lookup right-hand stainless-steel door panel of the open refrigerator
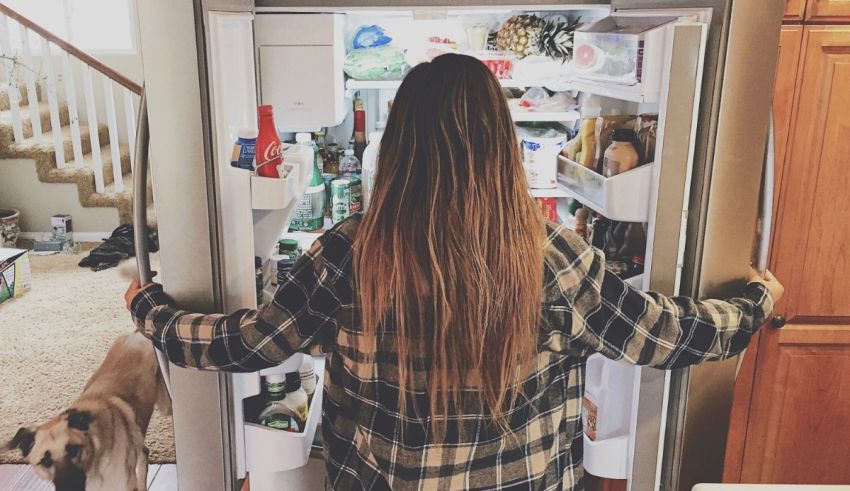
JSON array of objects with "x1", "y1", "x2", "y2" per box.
[{"x1": 612, "y1": 0, "x2": 783, "y2": 490}]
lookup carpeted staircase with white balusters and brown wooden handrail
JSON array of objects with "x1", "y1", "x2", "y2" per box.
[{"x1": 0, "y1": 4, "x2": 156, "y2": 228}]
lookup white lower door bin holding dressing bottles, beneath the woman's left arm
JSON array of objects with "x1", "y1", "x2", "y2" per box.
[{"x1": 238, "y1": 354, "x2": 325, "y2": 478}]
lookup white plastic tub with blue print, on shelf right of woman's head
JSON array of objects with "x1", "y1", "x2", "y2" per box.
[{"x1": 517, "y1": 126, "x2": 567, "y2": 189}]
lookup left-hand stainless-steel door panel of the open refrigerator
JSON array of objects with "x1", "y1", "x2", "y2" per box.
[{"x1": 138, "y1": 0, "x2": 235, "y2": 491}]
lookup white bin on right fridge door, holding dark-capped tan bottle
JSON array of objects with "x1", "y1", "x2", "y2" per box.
[{"x1": 558, "y1": 156, "x2": 655, "y2": 222}]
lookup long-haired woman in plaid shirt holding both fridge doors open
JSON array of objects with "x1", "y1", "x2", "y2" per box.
[{"x1": 127, "y1": 55, "x2": 782, "y2": 490}]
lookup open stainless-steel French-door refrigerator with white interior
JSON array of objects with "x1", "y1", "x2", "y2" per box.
[{"x1": 136, "y1": 0, "x2": 784, "y2": 491}]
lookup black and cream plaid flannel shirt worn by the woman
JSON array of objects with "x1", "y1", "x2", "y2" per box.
[{"x1": 131, "y1": 215, "x2": 773, "y2": 491}]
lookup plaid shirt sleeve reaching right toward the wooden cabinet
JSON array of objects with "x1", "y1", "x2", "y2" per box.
[{"x1": 544, "y1": 225, "x2": 773, "y2": 369}]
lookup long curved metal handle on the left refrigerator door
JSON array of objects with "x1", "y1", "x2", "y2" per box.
[{"x1": 133, "y1": 86, "x2": 171, "y2": 396}]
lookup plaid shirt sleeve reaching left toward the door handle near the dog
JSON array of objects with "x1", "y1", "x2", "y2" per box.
[{"x1": 131, "y1": 237, "x2": 340, "y2": 372}]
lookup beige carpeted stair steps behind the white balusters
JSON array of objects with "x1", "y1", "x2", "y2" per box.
[{"x1": 0, "y1": 84, "x2": 156, "y2": 229}]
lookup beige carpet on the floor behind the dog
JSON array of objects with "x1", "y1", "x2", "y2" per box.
[{"x1": 0, "y1": 248, "x2": 174, "y2": 463}]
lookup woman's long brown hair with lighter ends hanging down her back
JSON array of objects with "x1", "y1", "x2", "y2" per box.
[{"x1": 355, "y1": 55, "x2": 545, "y2": 433}]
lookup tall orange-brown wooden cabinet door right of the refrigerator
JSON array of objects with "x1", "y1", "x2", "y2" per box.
[{"x1": 740, "y1": 27, "x2": 850, "y2": 484}]
